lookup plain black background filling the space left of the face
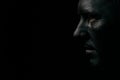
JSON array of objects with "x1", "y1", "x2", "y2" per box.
[{"x1": 3, "y1": 0, "x2": 90, "y2": 80}]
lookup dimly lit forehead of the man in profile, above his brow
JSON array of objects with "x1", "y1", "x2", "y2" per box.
[{"x1": 78, "y1": 0, "x2": 113, "y2": 12}]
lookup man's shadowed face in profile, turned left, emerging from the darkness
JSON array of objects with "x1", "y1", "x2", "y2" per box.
[{"x1": 74, "y1": 0, "x2": 118, "y2": 66}]
